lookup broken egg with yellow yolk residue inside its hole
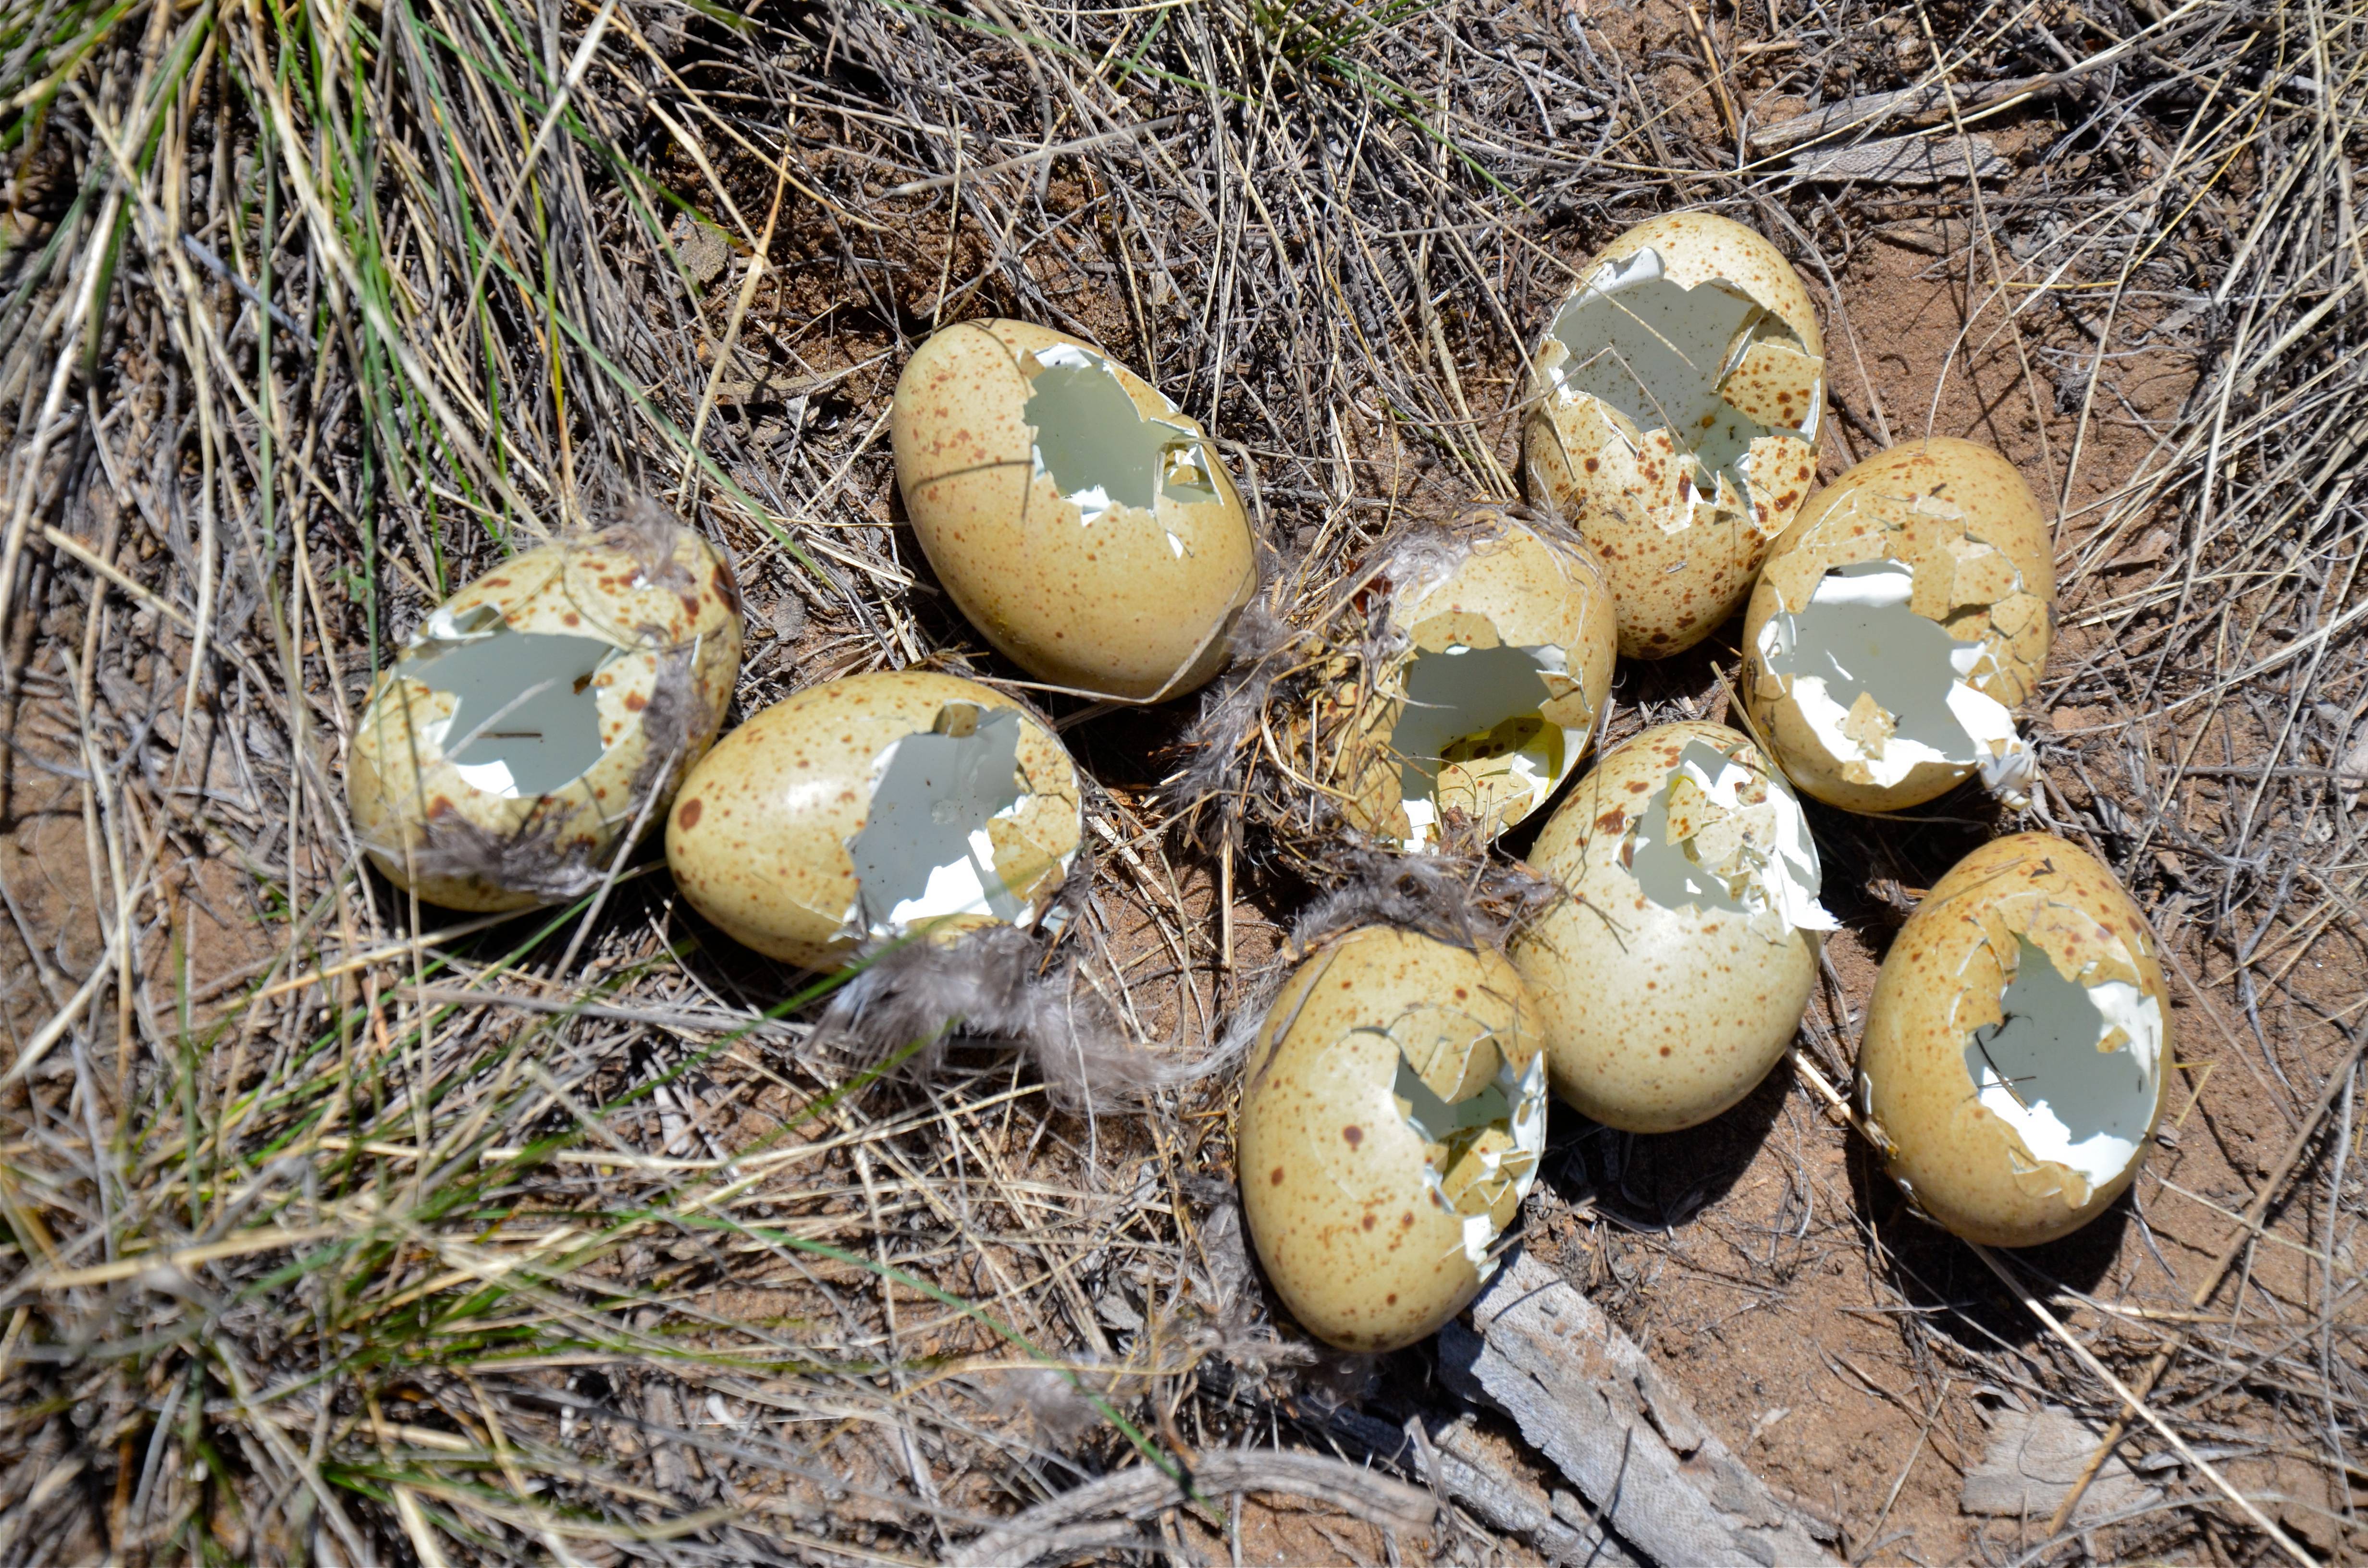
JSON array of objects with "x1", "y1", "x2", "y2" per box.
[{"x1": 1343, "y1": 507, "x2": 1617, "y2": 848}]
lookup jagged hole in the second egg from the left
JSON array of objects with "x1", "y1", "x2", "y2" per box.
[{"x1": 848, "y1": 703, "x2": 1066, "y2": 936}]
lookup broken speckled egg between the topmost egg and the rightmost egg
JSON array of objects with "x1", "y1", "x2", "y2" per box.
[{"x1": 1743, "y1": 436, "x2": 2056, "y2": 812}]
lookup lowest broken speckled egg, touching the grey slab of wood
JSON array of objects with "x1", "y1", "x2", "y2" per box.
[{"x1": 1236, "y1": 926, "x2": 1546, "y2": 1350}]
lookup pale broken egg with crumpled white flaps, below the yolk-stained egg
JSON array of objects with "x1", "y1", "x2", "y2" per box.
[{"x1": 1511, "y1": 723, "x2": 1833, "y2": 1132}]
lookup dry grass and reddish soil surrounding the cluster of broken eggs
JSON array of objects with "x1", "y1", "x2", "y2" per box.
[{"x1": 0, "y1": 0, "x2": 2368, "y2": 1563}]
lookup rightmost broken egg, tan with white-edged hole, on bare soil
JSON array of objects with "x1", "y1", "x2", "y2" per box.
[{"x1": 1859, "y1": 834, "x2": 2171, "y2": 1246}]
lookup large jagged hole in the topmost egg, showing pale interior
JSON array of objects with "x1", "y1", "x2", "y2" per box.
[{"x1": 1539, "y1": 246, "x2": 1824, "y2": 533}]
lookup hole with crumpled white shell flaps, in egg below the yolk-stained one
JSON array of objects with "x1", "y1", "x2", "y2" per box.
[{"x1": 1620, "y1": 741, "x2": 1838, "y2": 943}]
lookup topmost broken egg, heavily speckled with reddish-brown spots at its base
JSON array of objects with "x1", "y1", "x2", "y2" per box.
[{"x1": 1523, "y1": 213, "x2": 1825, "y2": 659}]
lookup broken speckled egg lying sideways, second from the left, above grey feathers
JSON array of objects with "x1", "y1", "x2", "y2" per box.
[{"x1": 666, "y1": 670, "x2": 1082, "y2": 969}]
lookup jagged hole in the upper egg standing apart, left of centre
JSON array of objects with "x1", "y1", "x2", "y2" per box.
[{"x1": 1021, "y1": 343, "x2": 1217, "y2": 557}]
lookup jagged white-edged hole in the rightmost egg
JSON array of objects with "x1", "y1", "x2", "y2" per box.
[{"x1": 1965, "y1": 936, "x2": 2162, "y2": 1189}]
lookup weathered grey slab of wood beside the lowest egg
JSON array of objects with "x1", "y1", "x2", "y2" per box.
[{"x1": 1440, "y1": 1253, "x2": 1835, "y2": 1568}]
